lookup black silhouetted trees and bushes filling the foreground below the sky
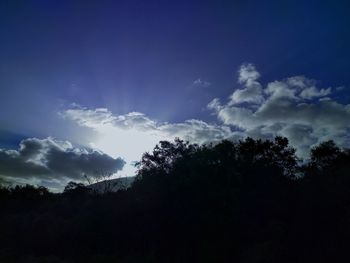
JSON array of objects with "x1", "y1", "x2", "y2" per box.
[{"x1": 0, "y1": 138, "x2": 350, "y2": 263}]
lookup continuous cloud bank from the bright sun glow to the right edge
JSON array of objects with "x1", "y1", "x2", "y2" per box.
[{"x1": 61, "y1": 64, "x2": 350, "y2": 165}]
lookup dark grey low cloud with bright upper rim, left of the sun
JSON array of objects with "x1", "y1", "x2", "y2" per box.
[{"x1": 0, "y1": 137, "x2": 125, "y2": 190}]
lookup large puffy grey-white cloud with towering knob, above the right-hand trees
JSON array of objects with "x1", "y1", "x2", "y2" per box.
[{"x1": 208, "y1": 64, "x2": 350, "y2": 156}]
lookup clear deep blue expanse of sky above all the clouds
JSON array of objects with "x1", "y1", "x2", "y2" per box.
[{"x1": 0, "y1": 0, "x2": 350, "y2": 188}]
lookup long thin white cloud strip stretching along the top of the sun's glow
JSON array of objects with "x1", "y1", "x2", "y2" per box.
[{"x1": 60, "y1": 107, "x2": 231, "y2": 146}]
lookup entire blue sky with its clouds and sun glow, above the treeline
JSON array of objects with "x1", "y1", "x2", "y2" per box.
[{"x1": 0, "y1": 0, "x2": 350, "y2": 190}]
